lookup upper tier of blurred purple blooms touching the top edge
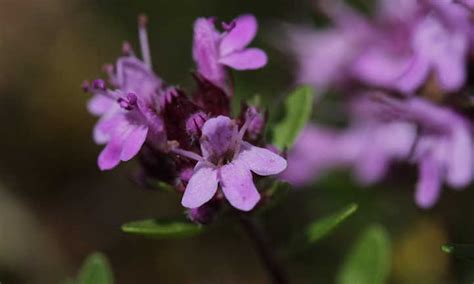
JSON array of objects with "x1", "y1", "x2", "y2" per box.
[{"x1": 290, "y1": 0, "x2": 472, "y2": 94}]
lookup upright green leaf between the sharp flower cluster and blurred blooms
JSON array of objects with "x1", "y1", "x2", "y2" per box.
[{"x1": 273, "y1": 86, "x2": 314, "y2": 150}]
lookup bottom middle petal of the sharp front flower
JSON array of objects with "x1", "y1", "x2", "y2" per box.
[{"x1": 219, "y1": 161, "x2": 260, "y2": 211}]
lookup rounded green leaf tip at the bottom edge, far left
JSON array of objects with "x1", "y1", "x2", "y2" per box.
[{"x1": 76, "y1": 253, "x2": 114, "y2": 284}]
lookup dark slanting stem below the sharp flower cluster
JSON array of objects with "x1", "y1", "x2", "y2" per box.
[{"x1": 239, "y1": 214, "x2": 289, "y2": 284}]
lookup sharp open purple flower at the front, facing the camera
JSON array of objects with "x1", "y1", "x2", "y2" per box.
[{"x1": 174, "y1": 116, "x2": 286, "y2": 211}]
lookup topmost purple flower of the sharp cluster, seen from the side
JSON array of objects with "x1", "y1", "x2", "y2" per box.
[{"x1": 193, "y1": 15, "x2": 267, "y2": 93}]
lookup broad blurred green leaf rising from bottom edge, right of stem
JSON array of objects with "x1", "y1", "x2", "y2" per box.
[{"x1": 337, "y1": 225, "x2": 391, "y2": 284}]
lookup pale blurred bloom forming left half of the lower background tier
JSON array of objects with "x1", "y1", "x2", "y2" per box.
[{"x1": 281, "y1": 121, "x2": 416, "y2": 186}]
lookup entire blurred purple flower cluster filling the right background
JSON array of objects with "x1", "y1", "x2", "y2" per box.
[{"x1": 284, "y1": 0, "x2": 474, "y2": 208}]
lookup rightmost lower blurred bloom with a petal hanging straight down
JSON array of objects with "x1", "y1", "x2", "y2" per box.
[{"x1": 386, "y1": 98, "x2": 474, "y2": 208}]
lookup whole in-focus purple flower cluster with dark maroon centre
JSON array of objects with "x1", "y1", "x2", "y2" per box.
[{"x1": 83, "y1": 15, "x2": 286, "y2": 213}]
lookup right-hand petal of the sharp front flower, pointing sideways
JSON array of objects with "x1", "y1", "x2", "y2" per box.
[{"x1": 237, "y1": 142, "x2": 287, "y2": 176}]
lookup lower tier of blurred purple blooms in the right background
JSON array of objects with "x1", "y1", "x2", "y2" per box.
[{"x1": 282, "y1": 96, "x2": 474, "y2": 208}]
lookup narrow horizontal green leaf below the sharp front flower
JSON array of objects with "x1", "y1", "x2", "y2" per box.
[{"x1": 122, "y1": 219, "x2": 203, "y2": 238}]
